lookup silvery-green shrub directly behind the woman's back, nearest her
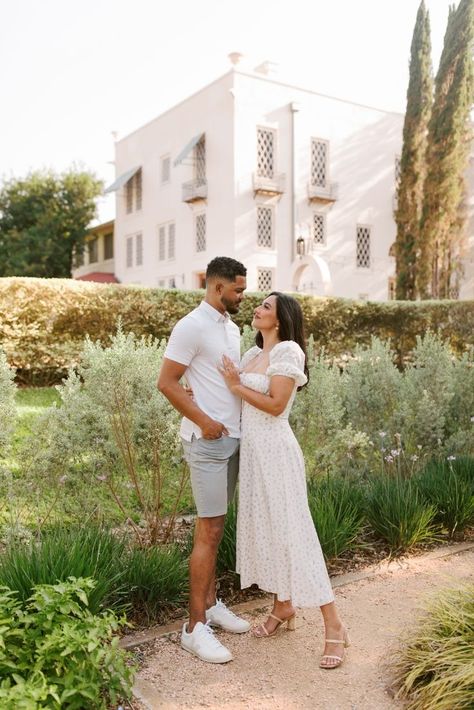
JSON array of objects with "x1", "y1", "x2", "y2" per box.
[{"x1": 291, "y1": 338, "x2": 369, "y2": 476}]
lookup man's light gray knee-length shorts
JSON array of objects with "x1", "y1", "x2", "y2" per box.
[{"x1": 181, "y1": 434, "x2": 240, "y2": 518}]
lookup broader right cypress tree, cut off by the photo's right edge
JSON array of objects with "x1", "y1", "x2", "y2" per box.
[{"x1": 417, "y1": 0, "x2": 474, "y2": 298}]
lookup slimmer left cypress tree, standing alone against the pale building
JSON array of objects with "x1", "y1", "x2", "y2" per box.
[{"x1": 395, "y1": 0, "x2": 433, "y2": 300}]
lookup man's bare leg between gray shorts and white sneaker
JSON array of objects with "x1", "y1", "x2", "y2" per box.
[{"x1": 188, "y1": 515, "x2": 225, "y2": 633}]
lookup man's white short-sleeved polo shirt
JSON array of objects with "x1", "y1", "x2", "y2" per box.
[{"x1": 164, "y1": 301, "x2": 240, "y2": 441}]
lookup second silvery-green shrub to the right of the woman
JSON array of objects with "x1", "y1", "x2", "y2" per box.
[{"x1": 342, "y1": 338, "x2": 402, "y2": 441}]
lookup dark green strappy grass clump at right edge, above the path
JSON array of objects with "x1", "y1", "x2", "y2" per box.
[{"x1": 415, "y1": 460, "x2": 474, "y2": 537}]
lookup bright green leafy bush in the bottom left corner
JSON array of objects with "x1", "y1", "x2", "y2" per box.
[{"x1": 0, "y1": 577, "x2": 134, "y2": 710}]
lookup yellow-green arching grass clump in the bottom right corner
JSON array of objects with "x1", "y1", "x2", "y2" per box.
[{"x1": 395, "y1": 584, "x2": 474, "y2": 710}]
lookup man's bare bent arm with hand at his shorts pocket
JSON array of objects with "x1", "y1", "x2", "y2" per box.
[{"x1": 157, "y1": 357, "x2": 229, "y2": 439}]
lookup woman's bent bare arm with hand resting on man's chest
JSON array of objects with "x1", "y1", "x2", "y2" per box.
[{"x1": 218, "y1": 355, "x2": 295, "y2": 417}]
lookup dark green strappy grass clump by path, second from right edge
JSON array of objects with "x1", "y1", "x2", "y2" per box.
[{"x1": 365, "y1": 475, "x2": 436, "y2": 553}]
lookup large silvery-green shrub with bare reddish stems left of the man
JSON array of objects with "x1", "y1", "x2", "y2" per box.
[{"x1": 26, "y1": 327, "x2": 181, "y2": 528}]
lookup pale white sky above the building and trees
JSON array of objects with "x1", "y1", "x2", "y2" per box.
[{"x1": 0, "y1": 0, "x2": 456, "y2": 195}]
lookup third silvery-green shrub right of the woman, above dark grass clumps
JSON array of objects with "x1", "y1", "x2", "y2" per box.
[{"x1": 396, "y1": 333, "x2": 455, "y2": 453}]
